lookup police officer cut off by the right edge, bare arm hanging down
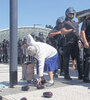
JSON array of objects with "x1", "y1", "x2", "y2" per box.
[{"x1": 81, "y1": 16, "x2": 90, "y2": 82}]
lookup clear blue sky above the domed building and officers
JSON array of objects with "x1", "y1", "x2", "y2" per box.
[{"x1": 0, "y1": 0, "x2": 90, "y2": 29}]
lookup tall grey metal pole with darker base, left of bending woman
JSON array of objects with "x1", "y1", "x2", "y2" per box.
[{"x1": 10, "y1": 0, "x2": 17, "y2": 87}]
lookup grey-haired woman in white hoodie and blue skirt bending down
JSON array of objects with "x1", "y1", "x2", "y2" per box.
[{"x1": 27, "y1": 34, "x2": 59, "y2": 86}]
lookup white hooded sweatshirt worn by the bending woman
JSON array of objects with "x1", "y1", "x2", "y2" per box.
[{"x1": 27, "y1": 34, "x2": 57, "y2": 77}]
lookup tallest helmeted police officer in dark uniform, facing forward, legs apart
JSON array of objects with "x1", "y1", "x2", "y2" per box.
[{"x1": 63, "y1": 7, "x2": 82, "y2": 80}]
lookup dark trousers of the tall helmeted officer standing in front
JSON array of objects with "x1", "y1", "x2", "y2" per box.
[{"x1": 63, "y1": 42, "x2": 82, "y2": 77}]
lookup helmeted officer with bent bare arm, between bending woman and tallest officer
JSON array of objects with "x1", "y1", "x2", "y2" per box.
[{"x1": 48, "y1": 17, "x2": 72, "y2": 77}]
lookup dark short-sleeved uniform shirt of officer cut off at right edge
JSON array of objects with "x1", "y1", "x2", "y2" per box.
[{"x1": 81, "y1": 18, "x2": 90, "y2": 41}]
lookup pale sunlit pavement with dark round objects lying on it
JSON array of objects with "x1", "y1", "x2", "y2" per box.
[{"x1": 0, "y1": 64, "x2": 90, "y2": 100}]
